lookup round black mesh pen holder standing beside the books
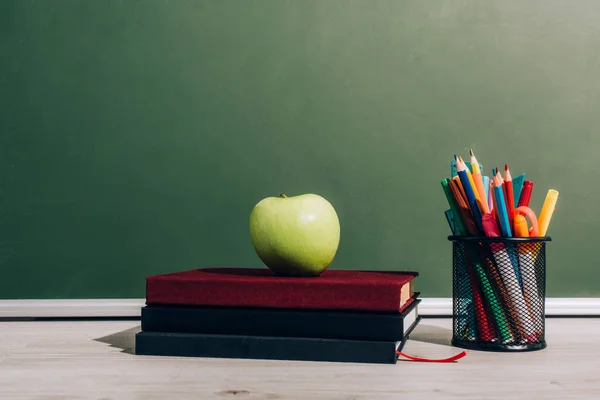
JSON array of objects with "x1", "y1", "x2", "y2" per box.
[{"x1": 448, "y1": 236, "x2": 551, "y2": 351}]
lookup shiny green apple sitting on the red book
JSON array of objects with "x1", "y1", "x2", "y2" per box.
[{"x1": 250, "y1": 194, "x2": 340, "y2": 276}]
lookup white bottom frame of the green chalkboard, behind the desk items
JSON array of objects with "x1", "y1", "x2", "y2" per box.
[{"x1": 0, "y1": 297, "x2": 600, "y2": 318}]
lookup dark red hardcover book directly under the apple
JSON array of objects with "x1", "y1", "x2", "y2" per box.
[{"x1": 146, "y1": 268, "x2": 418, "y2": 312}]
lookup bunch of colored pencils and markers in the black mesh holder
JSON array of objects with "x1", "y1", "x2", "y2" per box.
[{"x1": 442, "y1": 149, "x2": 558, "y2": 344}]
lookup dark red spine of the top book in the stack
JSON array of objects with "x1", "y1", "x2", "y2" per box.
[{"x1": 146, "y1": 278, "x2": 408, "y2": 312}]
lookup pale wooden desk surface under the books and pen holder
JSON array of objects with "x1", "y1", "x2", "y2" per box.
[{"x1": 0, "y1": 319, "x2": 600, "y2": 400}]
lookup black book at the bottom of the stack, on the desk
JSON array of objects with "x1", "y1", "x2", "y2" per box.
[{"x1": 135, "y1": 332, "x2": 404, "y2": 364}]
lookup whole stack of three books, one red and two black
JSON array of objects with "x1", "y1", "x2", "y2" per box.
[{"x1": 136, "y1": 268, "x2": 420, "y2": 364}]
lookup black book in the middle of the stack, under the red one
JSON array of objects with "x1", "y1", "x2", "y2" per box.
[{"x1": 141, "y1": 299, "x2": 420, "y2": 342}]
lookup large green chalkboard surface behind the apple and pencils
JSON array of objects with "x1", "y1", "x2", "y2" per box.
[{"x1": 0, "y1": 0, "x2": 600, "y2": 299}]
